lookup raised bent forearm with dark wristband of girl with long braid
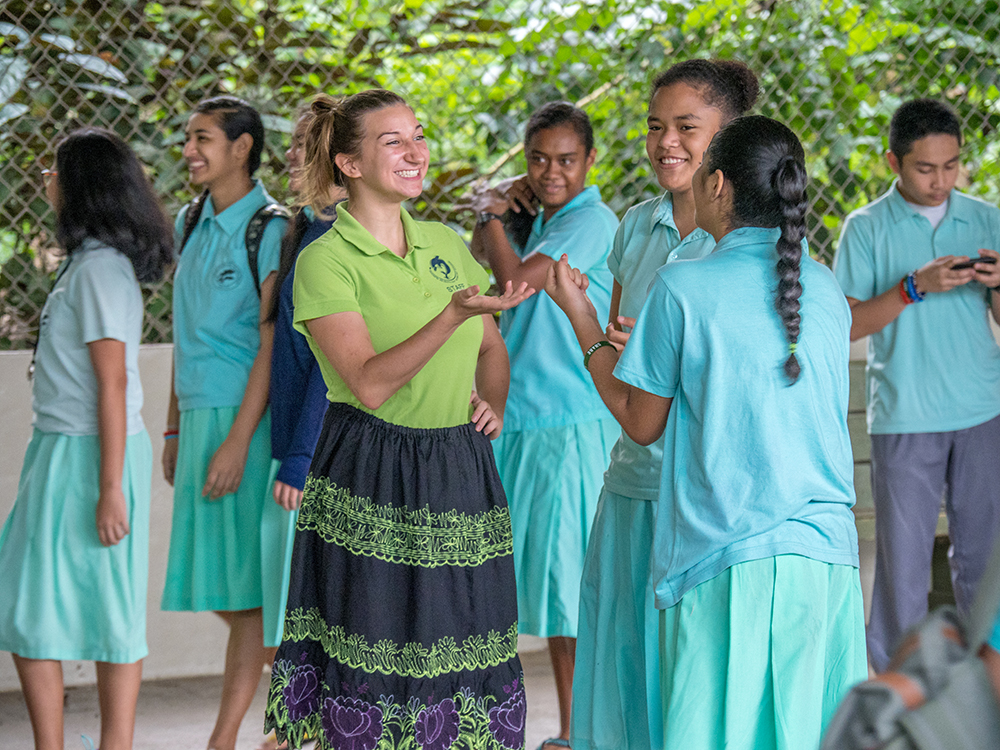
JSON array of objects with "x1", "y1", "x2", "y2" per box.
[{"x1": 545, "y1": 255, "x2": 673, "y2": 445}]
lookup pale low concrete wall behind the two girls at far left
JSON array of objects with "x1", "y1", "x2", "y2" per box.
[{"x1": 0, "y1": 345, "x2": 228, "y2": 690}]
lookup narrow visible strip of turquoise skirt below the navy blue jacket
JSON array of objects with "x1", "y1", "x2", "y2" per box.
[{"x1": 260, "y1": 460, "x2": 299, "y2": 648}]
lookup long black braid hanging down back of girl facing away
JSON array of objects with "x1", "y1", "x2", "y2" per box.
[{"x1": 771, "y1": 155, "x2": 809, "y2": 383}]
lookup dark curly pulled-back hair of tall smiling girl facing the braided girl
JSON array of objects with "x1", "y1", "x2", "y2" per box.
[{"x1": 649, "y1": 60, "x2": 760, "y2": 123}]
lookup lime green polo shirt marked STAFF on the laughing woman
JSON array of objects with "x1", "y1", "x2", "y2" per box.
[{"x1": 292, "y1": 203, "x2": 489, "y2": 428}]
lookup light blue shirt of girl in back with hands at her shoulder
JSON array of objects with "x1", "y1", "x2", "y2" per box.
[{"x1": 500, "y1": 186, "x2": 618, "y2": 431}]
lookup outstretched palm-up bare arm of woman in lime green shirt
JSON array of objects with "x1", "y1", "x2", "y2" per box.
[{"x1": 306, "y1": 282, "x2": 535, "y2": 409}]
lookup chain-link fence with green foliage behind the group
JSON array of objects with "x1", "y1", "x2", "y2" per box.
[{"x1": 0, "y1": 0, "x2": 1000, "y2": 349}]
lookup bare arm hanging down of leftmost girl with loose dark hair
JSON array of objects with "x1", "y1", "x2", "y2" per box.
[{"x1": 87, "y1": 339, "x2": 129, "y2": 547}]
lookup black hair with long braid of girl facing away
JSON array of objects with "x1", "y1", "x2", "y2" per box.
[{"x1": 705, "y1": 115, "x2": 809, "y2": 383}]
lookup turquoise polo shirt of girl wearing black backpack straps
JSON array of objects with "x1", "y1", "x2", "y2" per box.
[{"x1": 174, "y1": 180, "x2": 287, "y2": 411}]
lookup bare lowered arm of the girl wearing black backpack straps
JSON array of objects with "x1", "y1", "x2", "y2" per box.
[{"x1": 201, "y1": 272, "x2": 277, "y2": 500}]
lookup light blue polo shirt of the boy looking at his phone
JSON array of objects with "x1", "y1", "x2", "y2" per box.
[{"x1": 833, "y1": 183, "x2": 1000, "y2": 435}]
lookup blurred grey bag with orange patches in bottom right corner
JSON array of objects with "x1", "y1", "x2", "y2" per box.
[{"x1": 820, "y1": 544, "x2": 1000, "y2": 750}]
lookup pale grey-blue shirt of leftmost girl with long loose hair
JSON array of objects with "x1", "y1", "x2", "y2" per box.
[{"x1": 32, "y1": 239, "x2": 143, "y2": 435}]
